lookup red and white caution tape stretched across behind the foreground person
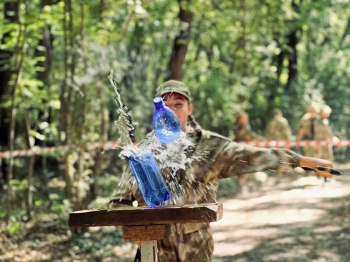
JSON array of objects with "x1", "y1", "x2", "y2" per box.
[{"x1": 0, "y1": 140, "x2": 350, "y2": 158}]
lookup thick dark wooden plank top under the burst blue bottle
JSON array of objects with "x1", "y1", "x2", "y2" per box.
[{"x1": 68, "y1": 203, "x2": 223, "y2": 227}]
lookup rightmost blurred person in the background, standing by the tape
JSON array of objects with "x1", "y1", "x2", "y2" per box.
[{"x1": 315, "y1": 105, "x2": 334, "y2": 161}]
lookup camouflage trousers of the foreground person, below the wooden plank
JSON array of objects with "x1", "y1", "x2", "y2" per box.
[{"x1": 158, "y1": 228, "x2": 214, "y2": 262}]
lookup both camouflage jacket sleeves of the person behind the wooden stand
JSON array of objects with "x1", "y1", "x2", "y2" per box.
[{"x1": 113, "y1": 131, "x2": 299, "y2": 205}]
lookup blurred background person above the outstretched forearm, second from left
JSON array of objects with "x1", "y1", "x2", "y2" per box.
[{"x1": 265, "y1": 109, "x2": 292, "y2": 141}]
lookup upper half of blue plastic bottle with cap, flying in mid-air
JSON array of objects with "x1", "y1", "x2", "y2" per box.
[{"x1": 153, "y1": 96, "x2": 181, "y2": 144}]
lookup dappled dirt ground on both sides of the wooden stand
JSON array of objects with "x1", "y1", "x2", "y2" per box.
[{"x1": 0, "y1": 165, "x2": 350, "y2": 262}]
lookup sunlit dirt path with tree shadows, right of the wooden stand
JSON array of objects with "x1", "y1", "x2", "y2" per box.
[{"x1": 212, "y1": 166, "x2": 350, "y2": 262}]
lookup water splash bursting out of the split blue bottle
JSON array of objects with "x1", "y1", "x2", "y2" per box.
[{"x1": 109, "y1": 73, "x2": 215, "y2": 208}]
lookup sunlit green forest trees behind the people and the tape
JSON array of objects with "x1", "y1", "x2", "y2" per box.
[{"x1": 0, "y1": 0, "x2": 350, "y2": 260}]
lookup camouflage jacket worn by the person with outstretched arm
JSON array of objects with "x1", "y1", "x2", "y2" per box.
[{"x1": 110, "y1": 117, "x2": 300, "y2": 234}]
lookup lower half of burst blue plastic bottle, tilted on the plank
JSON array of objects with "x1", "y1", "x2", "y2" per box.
[{"x1": 128, "y1": 151, "x2": 170, "y2": 208}]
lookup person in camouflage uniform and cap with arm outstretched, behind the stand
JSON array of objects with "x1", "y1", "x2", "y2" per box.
[{"x1": 110, "y1": 80, "x2": 332, "y2": 262}]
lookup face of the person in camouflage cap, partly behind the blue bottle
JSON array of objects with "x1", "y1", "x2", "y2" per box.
[{"x1": 163, "y1": 93, "x2": 192, "y2": 131}]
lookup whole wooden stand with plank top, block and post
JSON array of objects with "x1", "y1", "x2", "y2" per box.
[{"x1": 69, "y1": 203, "x2": 223, "y2": 262}]
